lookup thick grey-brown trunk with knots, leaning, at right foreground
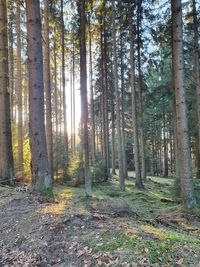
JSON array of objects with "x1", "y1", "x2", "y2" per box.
[{"x1": 171, "y1": 0, "x2": 196, "y2": 207}]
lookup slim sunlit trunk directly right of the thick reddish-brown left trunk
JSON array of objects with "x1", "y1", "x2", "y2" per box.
[{"x1": 44, "y1": 0, "x2": 53, "y2": 178}]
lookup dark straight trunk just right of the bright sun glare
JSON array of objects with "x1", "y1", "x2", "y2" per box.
[{"x1": 80, "y1": 0, "x2": 92, "y2": 197}]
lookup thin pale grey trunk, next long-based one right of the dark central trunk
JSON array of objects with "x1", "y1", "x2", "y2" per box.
[{"x1": 112, "y1": 0, "x2": 125, "y2": 191}]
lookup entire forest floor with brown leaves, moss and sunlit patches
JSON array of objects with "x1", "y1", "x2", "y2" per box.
[{"x1": 0, "y1": 177, "x2": 200, "y2": 267}]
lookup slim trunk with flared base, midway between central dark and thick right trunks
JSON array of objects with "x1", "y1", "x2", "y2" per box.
[{"x1": 128, "y1": 4, "x2": 144, "y2": 189}]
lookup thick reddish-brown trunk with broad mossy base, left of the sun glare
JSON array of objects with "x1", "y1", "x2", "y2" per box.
[{"x1": 26, "y1": 0, "x2": 52, "y2": 191}]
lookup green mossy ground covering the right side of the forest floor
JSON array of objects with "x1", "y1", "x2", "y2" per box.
[{"x1": 48, "y1": 178, "x2": 200, "y2": 266}]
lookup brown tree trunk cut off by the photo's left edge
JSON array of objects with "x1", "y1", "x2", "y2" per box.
[{"x1": 0, "y1": 1, "x2": 14, "y2": 185}]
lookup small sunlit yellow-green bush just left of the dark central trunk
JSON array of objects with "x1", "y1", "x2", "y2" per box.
[{"x1": 68, "y1": 155, "x2": 84, "y2": 186}]
